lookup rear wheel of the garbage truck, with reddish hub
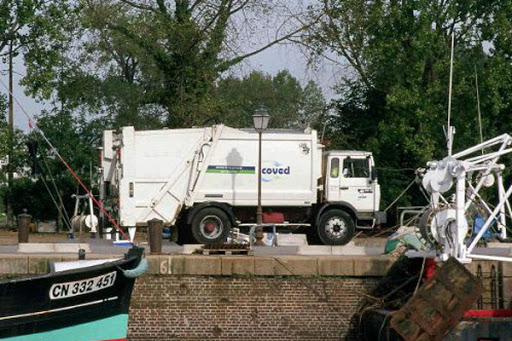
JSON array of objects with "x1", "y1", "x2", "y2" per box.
[{"x1": 192, "y1": 207, "x2": 231, "y2": 244}]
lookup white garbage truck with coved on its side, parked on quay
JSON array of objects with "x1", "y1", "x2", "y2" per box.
[{"x1": 99, "y1": 125, "x2": 385, "y2": 245}]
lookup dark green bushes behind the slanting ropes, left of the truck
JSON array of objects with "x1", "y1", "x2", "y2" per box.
[{"x1": 0, "y1": 111, "x2": 105, "y2": 220}]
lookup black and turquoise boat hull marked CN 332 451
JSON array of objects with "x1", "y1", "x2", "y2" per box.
[{"x1": 0, "y1": 249, "x2": 142, "y2": 341}]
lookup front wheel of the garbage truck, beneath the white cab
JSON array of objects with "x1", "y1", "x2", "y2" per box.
[{"x1": 317, "y1": 210, "x2": 355, "y2": 245}]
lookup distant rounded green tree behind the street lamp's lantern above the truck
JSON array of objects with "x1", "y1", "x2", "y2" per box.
[{"x1": 214, "y1": 70, "x2": 326, "y2": 129}]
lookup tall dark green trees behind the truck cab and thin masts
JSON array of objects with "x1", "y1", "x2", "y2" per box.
[{"x1": 302, "y1": 0, "x2": 512, "y2": 207}]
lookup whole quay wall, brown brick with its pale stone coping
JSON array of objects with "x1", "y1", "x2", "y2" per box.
[{"x1": 0, "y1": 254, "x2": 512, "y2": 341}]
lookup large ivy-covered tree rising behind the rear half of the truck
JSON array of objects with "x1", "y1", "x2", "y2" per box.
[{"x1": 30, "y1": 0, "x2": 312, "y2": 128}]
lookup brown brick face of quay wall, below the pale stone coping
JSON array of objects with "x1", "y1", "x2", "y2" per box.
[{"x1": 128, "y1": 274, "x2": 378, "y2": 341}]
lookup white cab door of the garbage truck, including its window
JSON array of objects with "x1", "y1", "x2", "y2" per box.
[{"x1": 339, "y1": 156, "x2": 375, "y2": 212}]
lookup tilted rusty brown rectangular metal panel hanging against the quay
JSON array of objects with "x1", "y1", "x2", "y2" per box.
[{"x1": 391, "y1": 258, "x2": 483, "y2": 341}]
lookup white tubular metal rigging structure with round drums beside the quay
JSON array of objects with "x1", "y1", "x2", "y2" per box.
[{"x1": 419, "y1": 134, "x2": 512, "y2": 262}]
